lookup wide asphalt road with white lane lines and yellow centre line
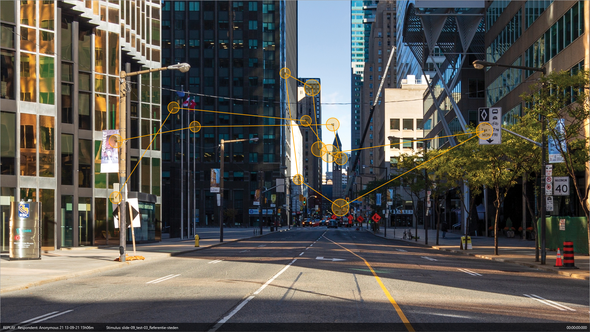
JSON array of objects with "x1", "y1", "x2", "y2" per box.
[{"x1": 0, "y1": 227, "x2": 589, "y2": 331}]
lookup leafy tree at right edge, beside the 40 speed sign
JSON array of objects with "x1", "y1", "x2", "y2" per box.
[{"x1": 522, "y1": 71, "x2": 590, "y2": 252}]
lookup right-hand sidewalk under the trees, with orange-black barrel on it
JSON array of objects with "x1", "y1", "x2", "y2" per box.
[{"x1": 363, "y1": 224, "x2": 590, "y2": 280}]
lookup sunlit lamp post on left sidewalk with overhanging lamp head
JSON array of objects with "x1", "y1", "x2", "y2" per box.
[{"x1": 119, "y1": 63, "x2": 191, "y2": 262}]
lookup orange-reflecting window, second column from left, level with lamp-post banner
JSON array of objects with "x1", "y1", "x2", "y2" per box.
[{"x1": 20, "y1": 113, "x2": 37, "y2": 176}]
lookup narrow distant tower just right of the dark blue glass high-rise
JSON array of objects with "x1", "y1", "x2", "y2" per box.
[{"x1": 297, "y1": 78, "x2": 322, "y2": 211}]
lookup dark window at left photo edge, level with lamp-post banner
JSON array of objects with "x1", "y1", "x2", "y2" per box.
[{"x1": 0, "y1": 112, "x2": 16, "y2": 175}]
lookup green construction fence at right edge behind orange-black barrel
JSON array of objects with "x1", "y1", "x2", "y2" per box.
[{"x1": 537, "y1": 217, "x2": 588, "y2": 255}]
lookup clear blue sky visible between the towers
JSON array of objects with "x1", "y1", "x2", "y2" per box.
[{"x1": 298, "y1": 0, "x2": 351, "y2": 150}]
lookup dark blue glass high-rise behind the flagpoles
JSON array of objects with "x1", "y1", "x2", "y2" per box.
[{"x1": 162, "y1": 0, "x2": 297, "y2": 237}]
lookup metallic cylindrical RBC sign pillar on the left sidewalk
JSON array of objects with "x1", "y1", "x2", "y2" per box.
[{"x1": 8, "y1": 201, "x2": 41, "y2": 260}]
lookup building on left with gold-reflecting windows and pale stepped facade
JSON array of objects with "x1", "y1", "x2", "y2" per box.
[{"x1": 0, "y1": 0, "x2": 162, "y2": 251}]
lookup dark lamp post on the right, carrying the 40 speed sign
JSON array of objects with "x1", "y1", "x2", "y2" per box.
[{"x1": 473, "y1": 60, "x2": 547, "y2": 265}]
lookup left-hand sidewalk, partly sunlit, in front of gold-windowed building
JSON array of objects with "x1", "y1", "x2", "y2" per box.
[{"x1": 0, "y1": 227, "x2": 287, "y2": 294}]
